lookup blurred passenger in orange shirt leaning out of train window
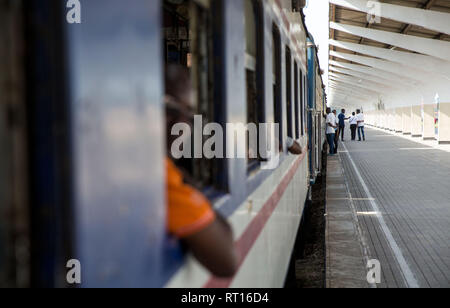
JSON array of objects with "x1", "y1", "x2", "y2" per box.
[{"x1": 165, "y1": 65, "x2": 238, "y2": 277}]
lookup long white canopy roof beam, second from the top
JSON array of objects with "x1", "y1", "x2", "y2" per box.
[{"x1": 330, "y1": 21, "x2": 450, "y2": 61}]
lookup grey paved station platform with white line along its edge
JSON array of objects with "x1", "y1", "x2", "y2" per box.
[{"x1": 326, "y1": 128, "x2": 450, "y2": 288}]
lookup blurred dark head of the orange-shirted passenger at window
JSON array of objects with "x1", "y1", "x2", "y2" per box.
[{"x1": 164, "y1": 65, "x2": 194, "y2": 151}]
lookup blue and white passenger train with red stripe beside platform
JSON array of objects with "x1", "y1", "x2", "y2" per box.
[{"x1": 0, "y1": 0, "x2": 326, "y2": 287}]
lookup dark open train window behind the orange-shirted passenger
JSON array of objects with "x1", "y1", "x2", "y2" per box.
[{"x1": 163, "y1": 0, "x2": 220, "y2": 189}]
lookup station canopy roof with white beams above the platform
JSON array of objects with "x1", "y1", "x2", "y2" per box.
[{"x1": 329, "y1": 0, "x2": 450, "y2": 109}]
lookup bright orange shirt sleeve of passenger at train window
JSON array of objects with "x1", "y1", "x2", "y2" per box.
[{"x1": 166, "y1": 159, "x2": 216, "y2": 238}]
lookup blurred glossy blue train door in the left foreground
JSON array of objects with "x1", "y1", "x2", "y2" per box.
[{"x1": 63, "y1": 0, "x2": 166, "y2": 287}]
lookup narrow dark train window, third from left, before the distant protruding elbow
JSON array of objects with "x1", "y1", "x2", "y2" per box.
[{"x1": 272, "y1": 25, "x2": 283, "y2": 146}]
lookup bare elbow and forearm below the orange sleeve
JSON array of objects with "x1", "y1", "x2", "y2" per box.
[{"x1": 183, "y1": 215, "x2": 238, "y2": 278}]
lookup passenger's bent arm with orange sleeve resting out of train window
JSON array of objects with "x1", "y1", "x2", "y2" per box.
[{"x1": 166, "y1": 160, "x2": 238, "y2": 277}]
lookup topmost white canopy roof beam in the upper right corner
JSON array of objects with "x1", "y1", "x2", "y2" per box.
[{"x1": 330, "y1": 0, "x2": 450, "y2": 34}]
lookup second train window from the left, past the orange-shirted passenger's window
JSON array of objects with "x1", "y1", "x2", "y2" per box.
[{"x1": 244, "y1": 0, "x2": 265, "y2": 170}]
